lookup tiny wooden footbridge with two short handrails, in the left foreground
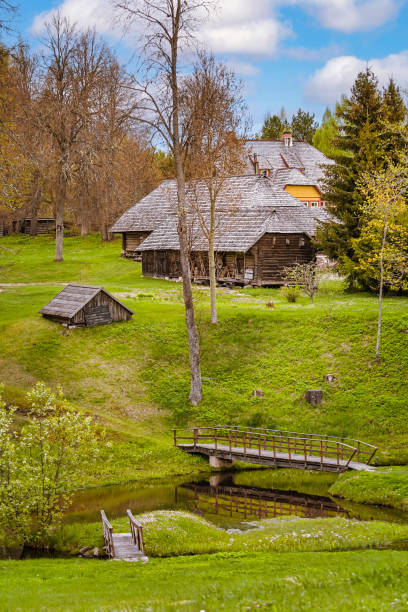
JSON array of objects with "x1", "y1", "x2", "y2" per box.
[{"x1": 101, "y1": 510, "x2": 147, "y2": 561}]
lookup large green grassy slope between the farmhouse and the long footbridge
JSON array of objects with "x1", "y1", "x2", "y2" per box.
[{"x1": 0, "y1": 236, "x2": 408, "y2": 482}]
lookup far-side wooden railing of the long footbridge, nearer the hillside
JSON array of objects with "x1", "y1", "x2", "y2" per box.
[{"x1": 174, "y1": 426, "x2": 377, "y2": 465}]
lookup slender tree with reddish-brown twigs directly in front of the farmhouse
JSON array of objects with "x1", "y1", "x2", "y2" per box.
[{"x1": 182, "y1": 53, "x2": 248, "y2": 323}]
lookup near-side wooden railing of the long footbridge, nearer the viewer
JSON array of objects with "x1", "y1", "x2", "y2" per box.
[{"x1": 174, "y1": 427, "x2": 357, "y2": 468}]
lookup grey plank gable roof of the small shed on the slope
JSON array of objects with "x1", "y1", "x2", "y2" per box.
[{"x1": 39, "y1": 283, "x2": 134, "y2": 319}]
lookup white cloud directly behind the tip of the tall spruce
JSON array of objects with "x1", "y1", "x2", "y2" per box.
[{"x1": 305, "y1": 51, "x2": 408, "y2": 104}]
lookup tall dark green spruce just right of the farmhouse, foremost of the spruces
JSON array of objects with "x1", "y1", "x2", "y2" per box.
[{"x1": 317, "y1": 68, "x2": 385, "y2": 286}]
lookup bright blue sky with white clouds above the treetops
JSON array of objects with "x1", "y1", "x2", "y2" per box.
[{"x1": 5, "y1": 0, "x2": 408, "y2": 129}]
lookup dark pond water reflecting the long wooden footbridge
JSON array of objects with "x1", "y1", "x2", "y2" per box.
[{"x1": 65, "y1": 470, "x2": 408, "y2": 529}]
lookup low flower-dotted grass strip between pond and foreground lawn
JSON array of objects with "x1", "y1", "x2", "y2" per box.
[{"x1": 49, "y1": 510, "x2": 408, "y2": 557}]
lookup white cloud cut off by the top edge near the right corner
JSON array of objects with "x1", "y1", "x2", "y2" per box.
[{"x1": 300, "y1": 0, "x2": 402, "y2": 33}]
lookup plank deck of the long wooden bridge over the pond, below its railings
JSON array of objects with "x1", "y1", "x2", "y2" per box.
[{"x1": 177, "y1": 442, "x2": 375, "y2": 472}]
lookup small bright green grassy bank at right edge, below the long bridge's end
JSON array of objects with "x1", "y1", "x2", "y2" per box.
[{"x1": 330, "y1": 466, "x2": 408, "y2": 511}]
